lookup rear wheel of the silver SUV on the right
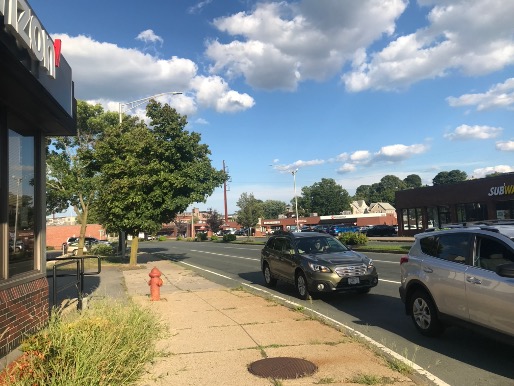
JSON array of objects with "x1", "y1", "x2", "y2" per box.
[{"x1": 410, "y1": 291, "x2": 444, "y2": 336}]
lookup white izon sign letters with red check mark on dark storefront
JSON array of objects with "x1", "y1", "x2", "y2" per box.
[{"x1": 0, "y1": 0, "x2": 61, "y2": 79}]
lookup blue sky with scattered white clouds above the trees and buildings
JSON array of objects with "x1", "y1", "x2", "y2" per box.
[{"x1": 28, "y1": 0, "x2": 514, "y2": 214}]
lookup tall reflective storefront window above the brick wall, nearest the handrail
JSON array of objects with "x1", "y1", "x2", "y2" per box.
[{"x1": 8, "y1": 130, "x2": 35, "y2": 277}]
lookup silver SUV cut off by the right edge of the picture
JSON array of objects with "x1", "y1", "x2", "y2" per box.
[{"x1": 400, "y1": 222, "x2": 514, "y2": 342}]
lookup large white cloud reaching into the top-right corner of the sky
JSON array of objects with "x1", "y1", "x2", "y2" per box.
[{"x1": 342, "y1": 0, "x2": 514, "y2": 92}]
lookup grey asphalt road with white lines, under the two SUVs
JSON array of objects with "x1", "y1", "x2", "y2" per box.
[{"x1": 136, "y1": 241, "x2": 514, "y2": 386}]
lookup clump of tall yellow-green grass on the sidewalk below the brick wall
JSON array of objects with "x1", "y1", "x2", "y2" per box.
[{"x1": 7, "y1": 301, "x2": 163, "y2": 386}]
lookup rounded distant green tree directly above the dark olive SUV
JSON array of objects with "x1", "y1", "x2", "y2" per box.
[{"x1": 298, "y1": 178, "x2": 350, "y2": 216}]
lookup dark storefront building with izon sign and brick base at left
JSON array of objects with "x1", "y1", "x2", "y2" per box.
[{"x1": 0, "y1": 0, "x2": 76, "y2": 357}]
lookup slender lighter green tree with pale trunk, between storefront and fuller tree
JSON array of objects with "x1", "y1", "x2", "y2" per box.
[{"x1": 46, "y1": 100, "x2": 117, "y2": 255}]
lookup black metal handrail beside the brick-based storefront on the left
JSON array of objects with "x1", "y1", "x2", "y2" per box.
[{"x1": 47, "y1": 256, "x2": 102, "y2": 310}]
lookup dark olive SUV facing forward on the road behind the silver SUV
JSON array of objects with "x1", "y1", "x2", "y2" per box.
[{"x1": 261, "y1": 232, "x2": 378, "y2": 299}]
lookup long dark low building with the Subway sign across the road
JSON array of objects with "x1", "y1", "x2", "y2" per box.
[{"x1": 396, "y1": 173, "x2": 514, "y2": 236}]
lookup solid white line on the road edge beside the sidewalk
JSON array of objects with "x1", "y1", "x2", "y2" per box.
[{"x1": 174, "y1": 260, "x2": 450, "y2": 386}]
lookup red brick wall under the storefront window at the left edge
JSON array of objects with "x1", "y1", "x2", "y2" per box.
[{"x1": 0, "y1": 277, "x2": 49, "y2": 357}]
